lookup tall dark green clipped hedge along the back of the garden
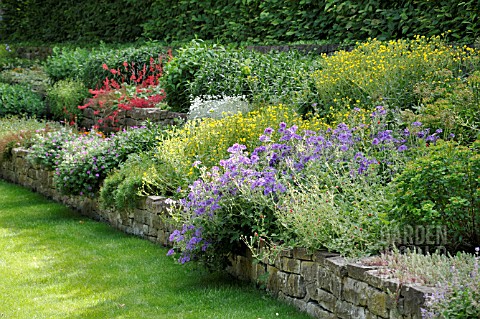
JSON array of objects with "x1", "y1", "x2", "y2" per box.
[{"x1": 0, "y1": 0, "x2": 480, "y2": 43}]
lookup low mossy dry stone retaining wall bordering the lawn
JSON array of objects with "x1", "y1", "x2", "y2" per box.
[{"x1": 0, "y1": 149, "x2": 434, "y2": 319}]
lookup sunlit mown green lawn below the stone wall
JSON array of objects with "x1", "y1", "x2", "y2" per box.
[{"x1": 0, "y1": 181, "x2": 308, "y2": 319}]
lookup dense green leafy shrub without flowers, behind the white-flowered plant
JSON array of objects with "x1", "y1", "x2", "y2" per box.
[{"x1": 161, "y1": 40, "x2": 319, "y2": 112}]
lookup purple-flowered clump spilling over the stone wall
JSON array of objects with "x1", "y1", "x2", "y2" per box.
[{"x1": 169, "y1": 116, "x2": 442, "y2": 264}]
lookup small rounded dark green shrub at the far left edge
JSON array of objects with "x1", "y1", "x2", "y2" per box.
[{"x1": 0, "y1": 83, "x2": 46, "y2": 117}]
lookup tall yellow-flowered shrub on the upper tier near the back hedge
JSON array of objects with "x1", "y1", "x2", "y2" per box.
[{"x1": 307, "y1": 37, "x2": 478, "y2": 115}]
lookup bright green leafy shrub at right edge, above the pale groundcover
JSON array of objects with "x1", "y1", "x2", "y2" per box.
[{"x1": 392, "y1": 141, "x2": 480, "y2": 251}]
